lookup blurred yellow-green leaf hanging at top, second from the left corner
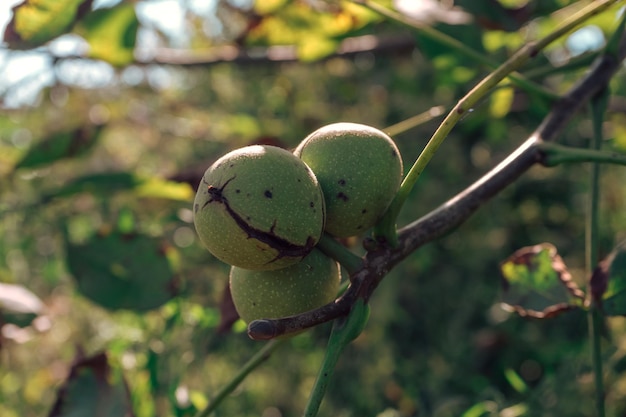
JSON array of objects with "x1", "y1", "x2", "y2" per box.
[{"x1": 77, "y1": 2, "x2": 139, "y2": 67}]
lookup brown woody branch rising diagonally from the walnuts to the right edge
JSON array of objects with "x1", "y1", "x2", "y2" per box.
[{"x1": 248, "y1": 35, "x2": 626, "y2": 340}]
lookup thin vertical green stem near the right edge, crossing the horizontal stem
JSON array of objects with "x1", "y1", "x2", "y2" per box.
[{"x1": 585, "y1": 90, "x2": 608, "y2": 417}]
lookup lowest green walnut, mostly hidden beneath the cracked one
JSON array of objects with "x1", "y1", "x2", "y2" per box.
[{"x1": 230, "y1": 249, "x2": 340, "y2": 323}]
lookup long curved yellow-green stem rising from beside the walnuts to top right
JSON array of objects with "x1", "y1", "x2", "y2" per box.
[{"x1": 372, "y1": 0, "x2": 616, "y2": 246}]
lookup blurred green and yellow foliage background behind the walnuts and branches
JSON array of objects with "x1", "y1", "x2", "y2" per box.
[{"x1": 0, "y1": 0, "x2": 626, "y2": 417}]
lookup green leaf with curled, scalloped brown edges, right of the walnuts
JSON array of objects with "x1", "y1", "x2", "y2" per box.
[{"x1": 500, "y1": 243, "x2": 585, "y2": 318}]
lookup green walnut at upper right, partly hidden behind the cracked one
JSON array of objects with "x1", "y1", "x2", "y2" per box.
[{"x1": 294, "y1": 123, "x2": 403, "y2": 237}]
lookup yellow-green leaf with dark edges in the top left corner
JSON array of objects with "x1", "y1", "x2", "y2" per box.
[{"x1": 4, "y1": 0, "x2": 92, "y2": 49}]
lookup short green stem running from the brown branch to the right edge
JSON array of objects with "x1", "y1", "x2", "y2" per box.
[{"x1": 538, "y1": 142, "x2": 626, "y2": 167}]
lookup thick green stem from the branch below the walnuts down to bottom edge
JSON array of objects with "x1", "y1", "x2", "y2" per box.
[{"x1": 304, "y1": 298, "x2": 369, "y2": 417}]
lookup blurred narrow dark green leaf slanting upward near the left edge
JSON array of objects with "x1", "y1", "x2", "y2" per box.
[{"x1": 14, "y1": 125, "x2": 105, "y2": 170}]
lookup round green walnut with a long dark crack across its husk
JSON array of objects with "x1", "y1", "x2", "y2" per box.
[{"x1": 193, "y1": 145, "x2": 325, "y2": 270}]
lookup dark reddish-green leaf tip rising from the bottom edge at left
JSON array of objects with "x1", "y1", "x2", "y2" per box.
[{"x1": 48, "y1": 353, "x2": 135, "y2": 417}]
